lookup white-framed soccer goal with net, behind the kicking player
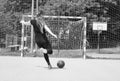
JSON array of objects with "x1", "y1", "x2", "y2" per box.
[{"x1": 21, "y1": 15, "x2": 86, "y2": 58}]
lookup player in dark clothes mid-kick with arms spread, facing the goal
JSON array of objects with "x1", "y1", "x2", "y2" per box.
[{"x1": 20, "y1": 14, "x2": 57, "y2": 69}]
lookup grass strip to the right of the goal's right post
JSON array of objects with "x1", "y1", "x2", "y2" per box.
[{"x1": 86, "y1": 47, "x2": 120, "y2": 60}]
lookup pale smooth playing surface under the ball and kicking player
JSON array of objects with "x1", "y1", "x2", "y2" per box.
[{"x1": 0, "y1": 56, "x2": 120, "y2": 81}]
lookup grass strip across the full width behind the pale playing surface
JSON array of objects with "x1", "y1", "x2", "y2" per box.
[{"x1": 0, "y1": 47, "x2": 120, "y2": 60}]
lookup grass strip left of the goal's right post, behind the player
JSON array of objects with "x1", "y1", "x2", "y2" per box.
[{"x1": 0, "y1": 49, "x2": 82, "y2": 58}]
